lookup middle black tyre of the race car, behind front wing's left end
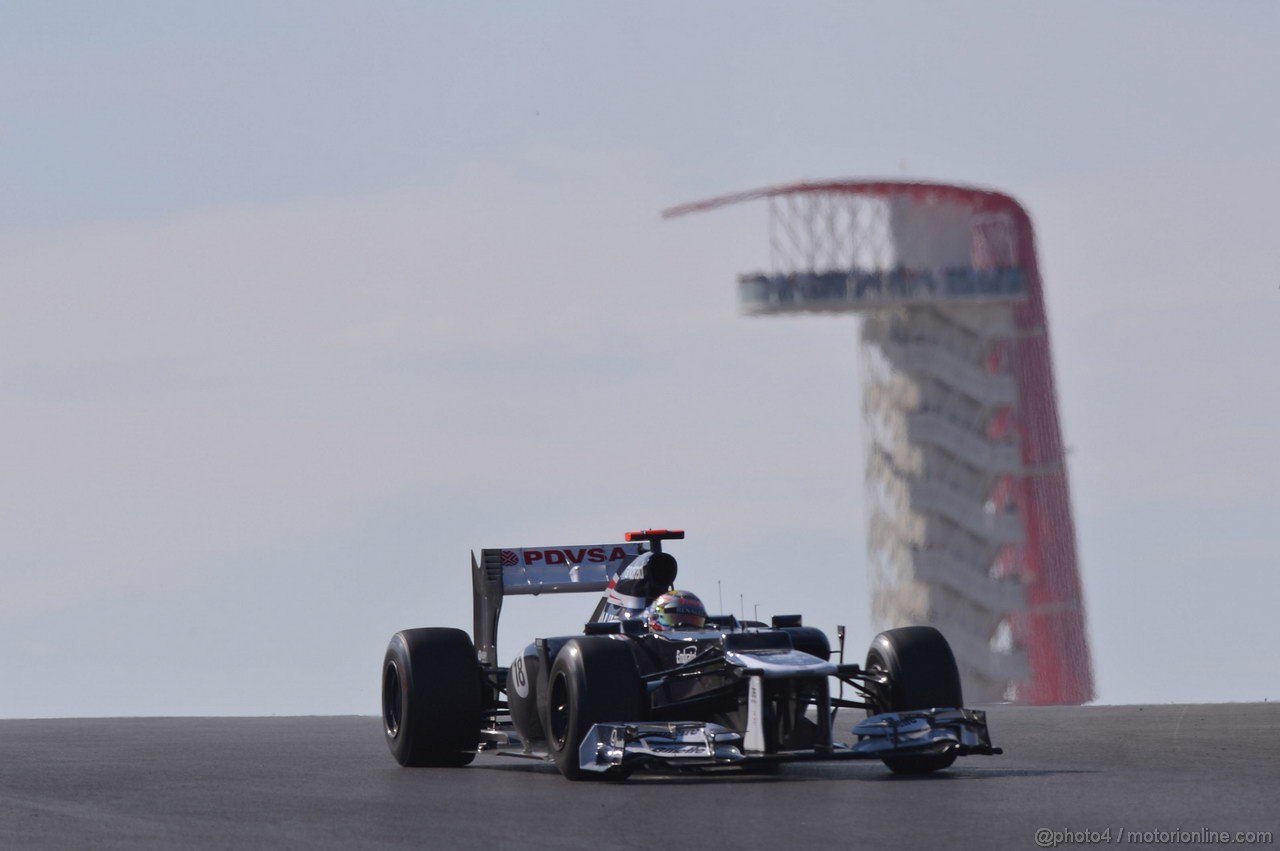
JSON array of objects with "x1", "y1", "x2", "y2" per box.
[{"x1": 547, "y1": 637, "x2": 644, "y2": 781}]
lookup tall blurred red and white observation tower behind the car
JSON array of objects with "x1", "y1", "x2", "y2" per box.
[{"x1": 663, "y1": 180, "x2": 1093, "y2": 704}]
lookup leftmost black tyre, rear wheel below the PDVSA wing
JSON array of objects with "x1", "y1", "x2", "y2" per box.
[{"x1": 383, "y1": 628, "x2": 481, "y2": 768}]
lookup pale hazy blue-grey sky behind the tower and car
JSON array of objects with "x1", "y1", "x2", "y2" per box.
[{"x1": 0, "y1": 0, "x2": 1280, "y2": 717}]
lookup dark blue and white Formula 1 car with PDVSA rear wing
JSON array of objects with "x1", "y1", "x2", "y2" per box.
[{"x1": 381, "y1": 530, "x2": 1001, "y2": 781}]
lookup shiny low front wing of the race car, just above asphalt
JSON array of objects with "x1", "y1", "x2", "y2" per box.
[{"x1": 579, "y1": 709, "x2": 1001, "y2": 774}]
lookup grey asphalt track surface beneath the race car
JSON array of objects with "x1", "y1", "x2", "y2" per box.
[{"x1": 0, "y1": 704, "x2": 1280, "y2": 851}]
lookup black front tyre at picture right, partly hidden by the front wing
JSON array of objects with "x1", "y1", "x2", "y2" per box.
[{"x1": 864, "y1": 627, "x2": 964, "y2": 774}]
